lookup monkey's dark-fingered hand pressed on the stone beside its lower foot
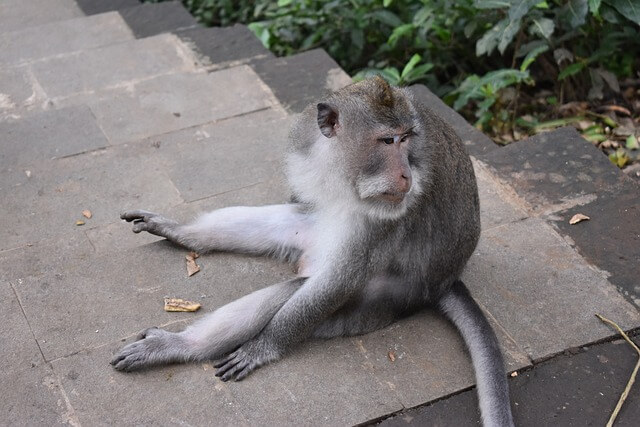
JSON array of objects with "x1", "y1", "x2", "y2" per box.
[{"x1": 214, "y1": 335, "x2": 283, "y2": 381}]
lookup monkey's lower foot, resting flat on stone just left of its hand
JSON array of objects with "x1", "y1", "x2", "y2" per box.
[{"x1": 111, "y1": 328, "x2": 184, "y2": 372}]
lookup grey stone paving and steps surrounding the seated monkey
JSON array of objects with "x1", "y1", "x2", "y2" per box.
[{"x1": 0, "y1": 0, "x2": 640, "y2": 425}]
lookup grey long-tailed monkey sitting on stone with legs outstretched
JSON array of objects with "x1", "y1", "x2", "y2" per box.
[{"x1": 111, "y1": 77, "x2": 513, "y2": 426}]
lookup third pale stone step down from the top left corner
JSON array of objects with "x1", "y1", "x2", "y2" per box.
[{"x1": 0, "y1": 32, "x2": 199, "y2": 119}]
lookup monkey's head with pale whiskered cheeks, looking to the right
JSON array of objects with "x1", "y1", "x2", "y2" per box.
[{"x1": 288, "y1": 77, "x2": 424, "y2": 219}]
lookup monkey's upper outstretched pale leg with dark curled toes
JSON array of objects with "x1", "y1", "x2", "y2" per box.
[{"x1": 120, "y1": 204, "x2": 312, "y2": 258}]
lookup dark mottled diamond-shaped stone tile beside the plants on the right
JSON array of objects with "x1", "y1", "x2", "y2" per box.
[{"x1": 479, "y1": 128, "x2": 628, "y2": 214}]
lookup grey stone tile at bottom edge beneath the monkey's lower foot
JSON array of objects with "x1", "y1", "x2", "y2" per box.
[{"x1": 52, "y1": 348, "x2": 248, "y2": 426}]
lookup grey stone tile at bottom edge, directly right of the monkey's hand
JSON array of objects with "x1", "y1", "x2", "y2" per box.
[{"x1": 228, "y1": 338, "x2": 402, "y2": 425}]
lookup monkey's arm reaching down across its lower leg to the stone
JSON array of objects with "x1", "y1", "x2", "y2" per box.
[{"x1": 215, "y1": 244, "x2": 371, "y2": 381}]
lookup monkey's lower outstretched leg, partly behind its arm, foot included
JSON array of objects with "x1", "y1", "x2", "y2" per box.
[{"x1": 111, "y1": 278, "x2": 305, "y2": 371}]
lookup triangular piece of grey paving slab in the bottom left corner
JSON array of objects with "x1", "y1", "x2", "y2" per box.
[{"x1": 0, "y1": 281, "x2": 69, "y2": 425}]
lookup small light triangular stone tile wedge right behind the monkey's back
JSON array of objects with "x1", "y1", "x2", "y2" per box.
[{"x1": 473, "y1": 159, "x2": 528, "y2": 230}]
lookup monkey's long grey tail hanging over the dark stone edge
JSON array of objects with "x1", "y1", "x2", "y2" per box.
[{"x1": 438, "y1": 280, "x2": 514, "y2": 427}]
